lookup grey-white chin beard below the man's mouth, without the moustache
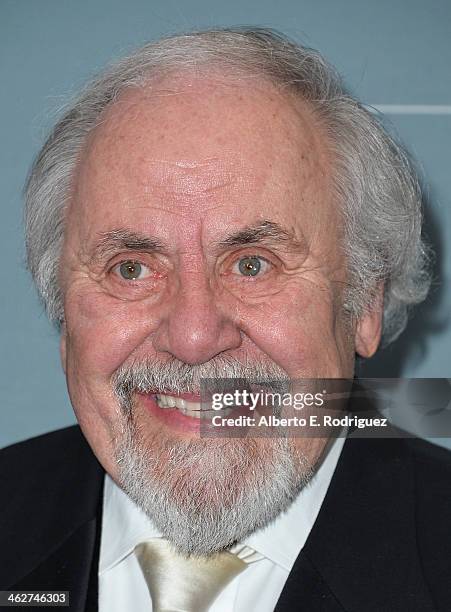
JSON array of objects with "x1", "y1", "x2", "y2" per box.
[{"x1": 116, "y1": 420, "x2": 314, "y2": 555}]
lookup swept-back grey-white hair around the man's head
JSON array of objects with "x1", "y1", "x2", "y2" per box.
[{"x1": 25, "y1": 27, "x2": 430, "y2": 343}]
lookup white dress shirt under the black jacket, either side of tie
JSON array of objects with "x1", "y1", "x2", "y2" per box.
[{"x1": 99, "y1": 438, "x2": 344, "y2": 612}]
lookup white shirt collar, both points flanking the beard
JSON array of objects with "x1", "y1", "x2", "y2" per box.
[{"x1": 99, "y1": 438, "x2": 344, "y2": 574}]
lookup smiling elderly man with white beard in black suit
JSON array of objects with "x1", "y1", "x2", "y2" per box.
[{"x1": 0, "y1": 28, "x2": 451, "y2": 612}]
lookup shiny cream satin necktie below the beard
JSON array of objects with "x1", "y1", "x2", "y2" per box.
[{"x1": 135, "y1": 538, "x2": 263, "y2": 612}]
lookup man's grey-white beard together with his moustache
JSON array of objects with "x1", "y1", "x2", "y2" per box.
[{"x1": 113, "y1": 356, "x2": 314, "y2": 555}]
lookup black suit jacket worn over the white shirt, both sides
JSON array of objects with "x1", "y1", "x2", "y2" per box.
[{"x1": 0, "y1": 427, "x2": 451, "y2": 612}]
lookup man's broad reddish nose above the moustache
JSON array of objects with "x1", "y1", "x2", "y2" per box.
[{"x1": 153, "y1": 278, "x2": 242, "y2": 365}]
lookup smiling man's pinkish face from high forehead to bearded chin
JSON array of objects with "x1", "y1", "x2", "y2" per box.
[{"x1": 61, "y1": 75, "x2": 380, "y2": 552}]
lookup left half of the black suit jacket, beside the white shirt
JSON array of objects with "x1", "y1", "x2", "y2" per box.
[{"x1": 0, "y1": 427, "x2": 104, "y2": 612}]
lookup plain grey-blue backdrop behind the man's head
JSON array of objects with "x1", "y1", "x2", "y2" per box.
[{"x1": 0, "y1": 0, "x2": 451, "y2": 446}]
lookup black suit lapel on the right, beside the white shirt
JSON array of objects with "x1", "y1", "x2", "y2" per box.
[{"x1": 276, "y1": 439, "x2": 434, "y2": 612}]
